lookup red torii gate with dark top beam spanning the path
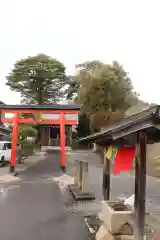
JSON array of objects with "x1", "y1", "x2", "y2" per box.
[{"x1": 0, "y1": 104, "x2": 81, "y2": 172}]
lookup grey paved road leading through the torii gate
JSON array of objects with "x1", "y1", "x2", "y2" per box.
[{"x1": 0, "y1": 154, "x2": 90, "y2": 240}]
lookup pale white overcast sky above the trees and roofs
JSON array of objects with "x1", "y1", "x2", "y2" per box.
[{"x1": 0, "y1": 0, "x2": 160, "y2": 104}]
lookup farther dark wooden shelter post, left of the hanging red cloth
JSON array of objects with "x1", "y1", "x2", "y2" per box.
[{"x1": 103, "y1": 150, "x2": 110, "y2": 201}]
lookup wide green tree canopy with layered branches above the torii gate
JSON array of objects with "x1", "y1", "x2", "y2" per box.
[{"x1": 6, "y1": 54, "x2": 66, "y2": 104}]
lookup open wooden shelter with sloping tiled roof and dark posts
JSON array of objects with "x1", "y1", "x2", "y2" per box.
[{"x1": 80, "y1": 106, "x2": 160, "y2": 240}]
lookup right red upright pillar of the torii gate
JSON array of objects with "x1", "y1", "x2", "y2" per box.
[{"x1": 60, "y1": 112, "x2": 66, "y2": 172}]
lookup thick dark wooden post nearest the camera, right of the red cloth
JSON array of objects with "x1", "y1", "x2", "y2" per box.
[{"x1": 134, "y1": 130, "x2": 147, "y2": 240}]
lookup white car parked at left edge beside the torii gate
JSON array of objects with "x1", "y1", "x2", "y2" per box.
[{"x1": 0, "y1": 141, "x2": 12, "y2": 165}]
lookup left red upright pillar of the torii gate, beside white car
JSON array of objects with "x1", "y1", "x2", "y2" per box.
[{"x1": 10, "y1": 113, "x2": 19, "y2": 173}]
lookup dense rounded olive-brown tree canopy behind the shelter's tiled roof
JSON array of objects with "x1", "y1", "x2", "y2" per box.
[{"x1": 68, "y1": 61, "x2": 137, "y2": 131}]
